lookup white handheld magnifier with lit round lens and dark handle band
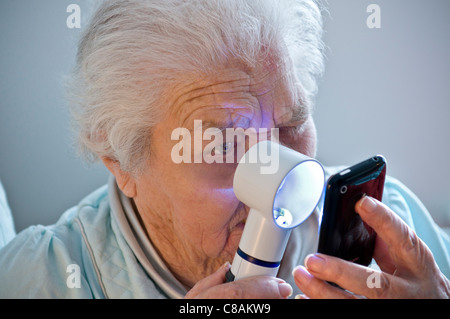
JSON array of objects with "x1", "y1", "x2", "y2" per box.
[{"x1": 226, "y1": 141, "x2": 325, "y2": 281}]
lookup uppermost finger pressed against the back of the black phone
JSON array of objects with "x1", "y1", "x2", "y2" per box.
[{"x1": 355, "y1": 196, "x2": 430, "y2": 275}]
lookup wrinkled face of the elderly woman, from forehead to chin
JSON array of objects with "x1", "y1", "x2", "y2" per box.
[{"x1": 128, "y1": 54, "x2": 315, "y2": 286}]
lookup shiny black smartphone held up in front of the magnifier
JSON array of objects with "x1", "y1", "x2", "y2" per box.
[{"x1": 317, "y1": 155, "x2": 386, "y2": 266}]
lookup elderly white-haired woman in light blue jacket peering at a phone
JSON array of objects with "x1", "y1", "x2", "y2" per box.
[{"x1": 0, "y1": 0, "x2": 450, "y2": 298}]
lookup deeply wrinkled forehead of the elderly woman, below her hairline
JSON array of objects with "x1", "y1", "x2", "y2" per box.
[{"x1": 163, "y1": 55, "x2": 308, "y2": 128}]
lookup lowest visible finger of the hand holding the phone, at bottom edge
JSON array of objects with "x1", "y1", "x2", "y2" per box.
[{"x1": 292, "y1": 266, "x2": 354, "y2": 299}]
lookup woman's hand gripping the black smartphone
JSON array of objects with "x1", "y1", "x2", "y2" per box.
[{"x1": 293, "y1": 197, "x2": 450, "y2": 298}]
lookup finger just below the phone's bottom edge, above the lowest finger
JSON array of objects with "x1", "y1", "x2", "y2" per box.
[{"x1": 305, "y1": 254, "x2": 404, "y2": 298}]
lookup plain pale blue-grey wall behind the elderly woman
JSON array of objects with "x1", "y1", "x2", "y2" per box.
[{"x1": 0, "y1": 0, "x2": 450, "y2": 231}]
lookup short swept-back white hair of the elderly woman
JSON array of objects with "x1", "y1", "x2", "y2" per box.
[{"x1": 69, "y1": 0, "x2": 324, "y2": 172}]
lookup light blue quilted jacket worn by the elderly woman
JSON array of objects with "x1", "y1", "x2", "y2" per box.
[{"x1": 0, "y1": 172, "x2": 450, "y2": 298}]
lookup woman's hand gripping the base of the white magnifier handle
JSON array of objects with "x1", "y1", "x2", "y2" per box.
[{"x1": 185, "y1": 263, "x2": 292, "y2": 299}]
